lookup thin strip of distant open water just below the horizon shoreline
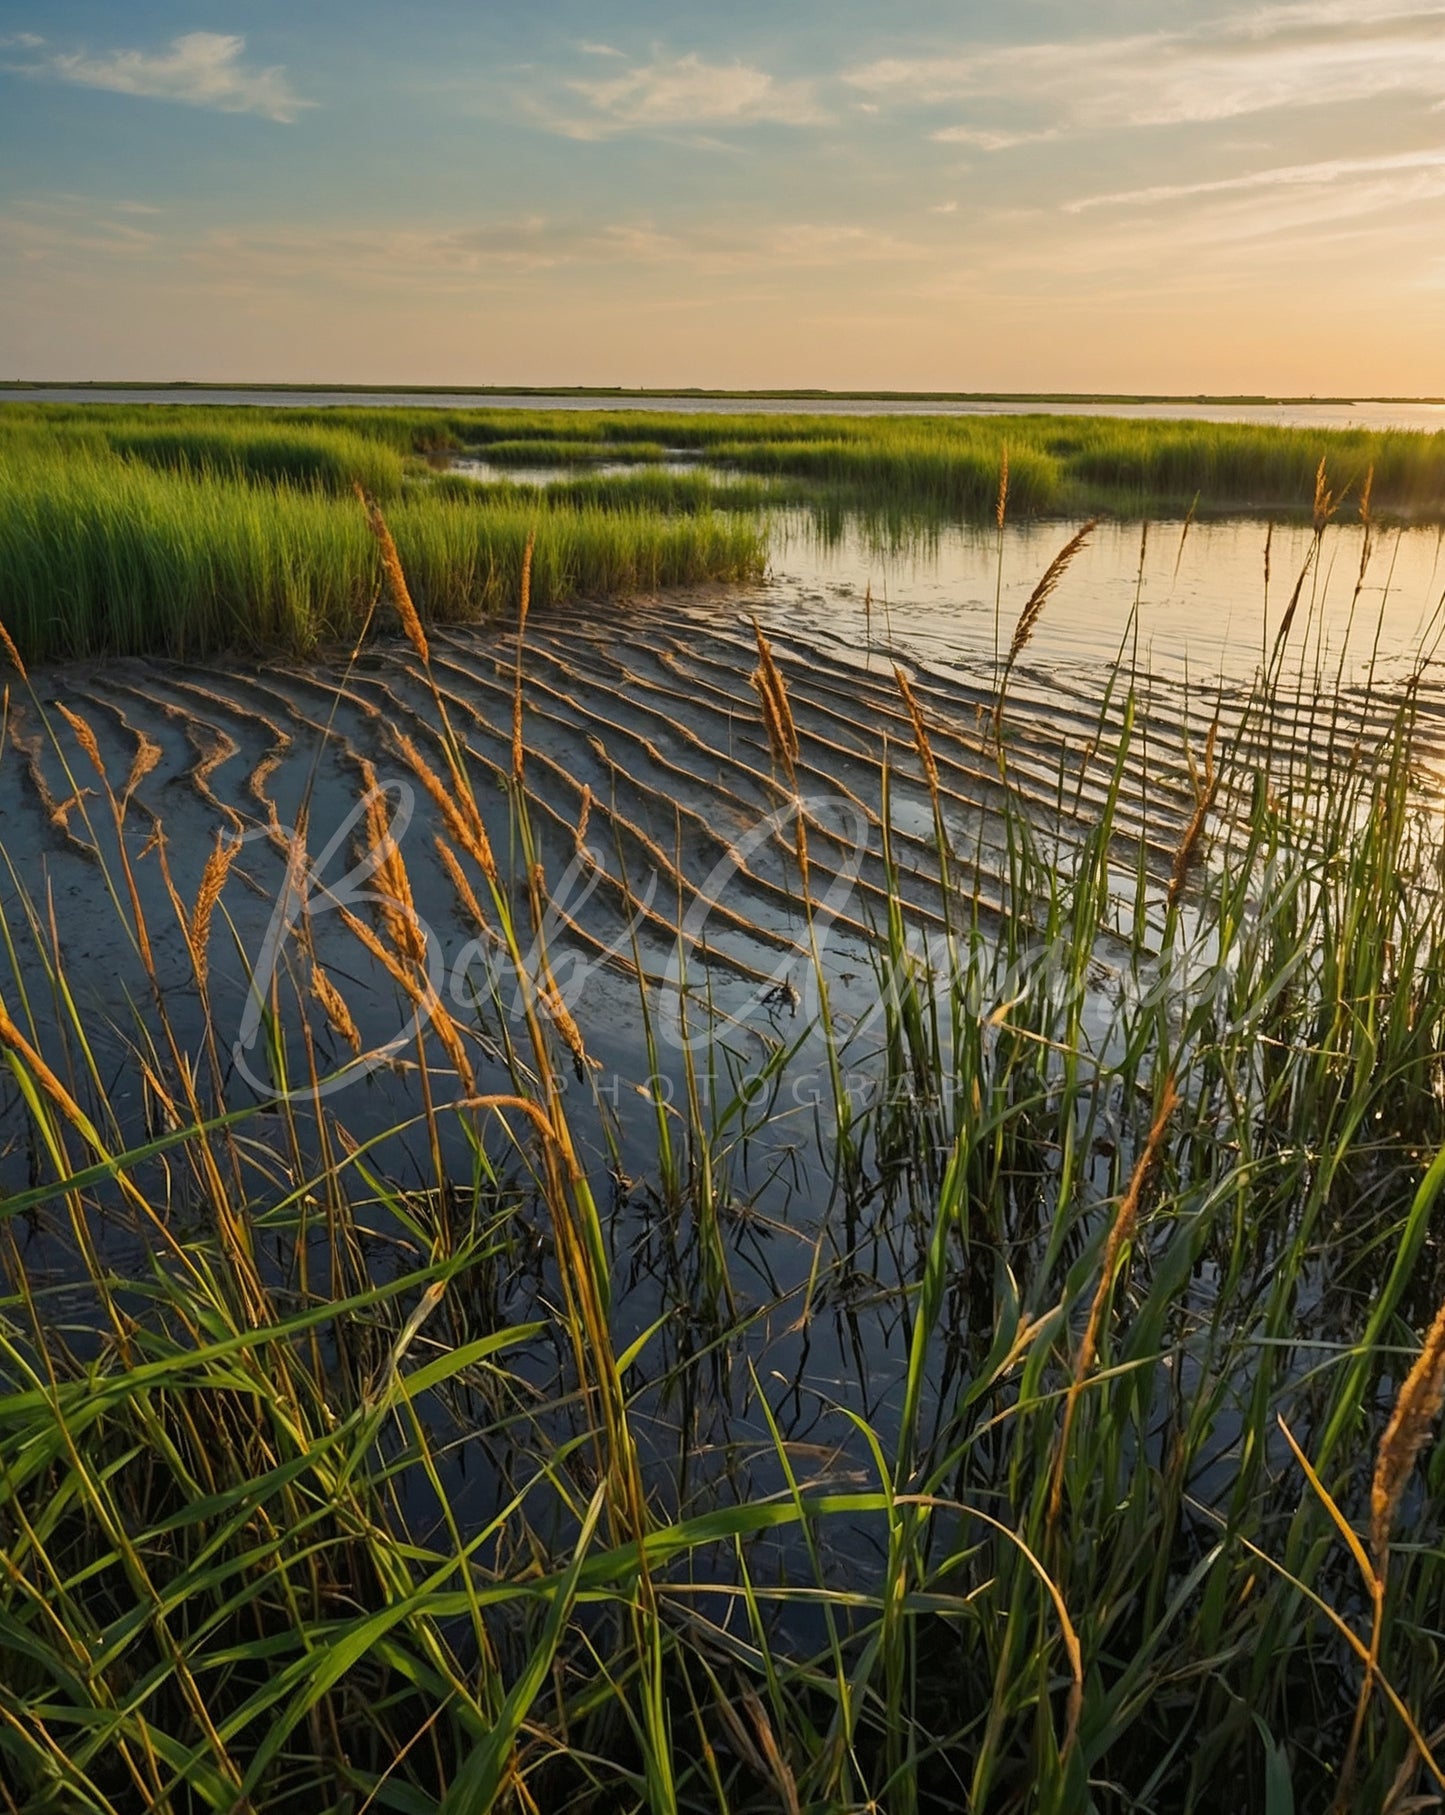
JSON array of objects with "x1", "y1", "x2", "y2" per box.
[{"x1": 0, "y1": 385, "x2": 1445, "y2": 430}]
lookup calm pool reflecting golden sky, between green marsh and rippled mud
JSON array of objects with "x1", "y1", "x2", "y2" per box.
[{"x1": 768, "y1": 519, "x2": 1445, "y2": 690}]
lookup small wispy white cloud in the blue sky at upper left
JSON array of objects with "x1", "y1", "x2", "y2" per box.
[{"x1": 9, "y1": 31, "x2": 314, "y2": 122}]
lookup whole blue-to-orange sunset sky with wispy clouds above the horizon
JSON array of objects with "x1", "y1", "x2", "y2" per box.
[{"x1": 0, "y1": 0, "x2": 1445, "y2": 396}]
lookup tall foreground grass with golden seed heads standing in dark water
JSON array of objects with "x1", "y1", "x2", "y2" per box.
[{"x1": 0, "y1": 461, "x2": 1445, "y2": 1815}]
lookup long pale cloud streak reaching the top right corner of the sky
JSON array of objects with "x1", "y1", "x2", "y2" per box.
[{"x1": 844, "y1": 0, "x2": 1445, "y2": 132}]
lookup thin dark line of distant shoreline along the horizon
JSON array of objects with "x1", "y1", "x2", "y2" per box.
[{"x1": 0, "y1": 378, "x2": 1445, "y2": 408}]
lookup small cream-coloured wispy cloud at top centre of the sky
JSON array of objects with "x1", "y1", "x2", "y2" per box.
[{"x1": 554, "y1": 53, "x2": 824, "y2": 138}]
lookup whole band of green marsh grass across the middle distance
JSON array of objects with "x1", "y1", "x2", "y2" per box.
[{"x1": 0, "y1": 403, "x2": 1445, "y2": 657}]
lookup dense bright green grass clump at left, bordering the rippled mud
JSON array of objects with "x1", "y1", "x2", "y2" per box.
[{"x1": 0, "y1": 416, "x2": 766, "y2": 659}]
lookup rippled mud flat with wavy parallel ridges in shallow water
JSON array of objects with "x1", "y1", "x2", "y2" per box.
[{"x1": 0, "y1": 597, "x2": 1445, "y2": 1045}]
